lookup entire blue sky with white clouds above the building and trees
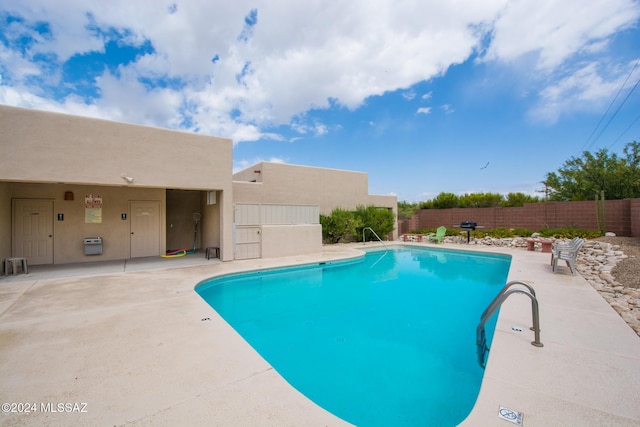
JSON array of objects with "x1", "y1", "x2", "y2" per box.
[{"x1": 0, "y1": 0, "x2": 640, "y2": 202}]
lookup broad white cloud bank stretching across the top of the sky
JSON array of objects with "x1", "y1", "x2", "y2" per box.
[{"x1": 0, "y1": 0, "x2": 640, "y2": 142}]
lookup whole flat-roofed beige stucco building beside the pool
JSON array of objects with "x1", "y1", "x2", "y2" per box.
[{"x1": 0, "y1": 106, "x2": 397, "y2": 265}]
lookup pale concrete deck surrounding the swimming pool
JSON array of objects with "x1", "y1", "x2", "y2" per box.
[{"x1": 0, "y1": 244, "x2": 640, "y2": 426}]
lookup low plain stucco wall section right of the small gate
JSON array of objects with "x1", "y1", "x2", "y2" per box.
[{"x1": 261, "y1": 224, "x2": 322, "y2": 258}]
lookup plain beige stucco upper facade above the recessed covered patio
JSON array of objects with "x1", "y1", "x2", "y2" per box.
[{"x1": 0, "y1": 106, "x2": 233, "y2": 190}]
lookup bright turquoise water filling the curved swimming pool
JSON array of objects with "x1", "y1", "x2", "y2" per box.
[{"x1": 196, "y1": 248, "x2": 511, "y2": 426}]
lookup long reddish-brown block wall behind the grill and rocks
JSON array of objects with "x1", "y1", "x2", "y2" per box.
[{"x1": 398, "y1": 199, "x2": 640, "y2": 237}]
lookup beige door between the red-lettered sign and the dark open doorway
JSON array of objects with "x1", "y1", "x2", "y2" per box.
[{"x1": 129, "y1": 201, "x2": 160, "y2": 258}]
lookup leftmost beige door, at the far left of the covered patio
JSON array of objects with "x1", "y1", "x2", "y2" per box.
[{"x1": 11, "y1": 199, "x2": 53, "y2": 265}]
